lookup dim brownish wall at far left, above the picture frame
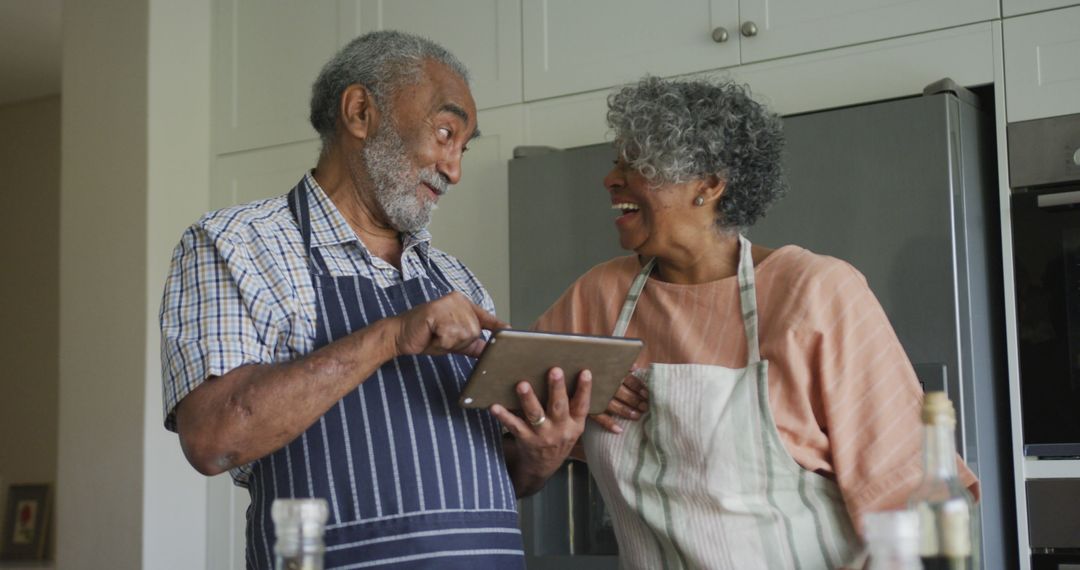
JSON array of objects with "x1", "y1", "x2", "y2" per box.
[{"x1": 0, "y1": 96, "x2": 60, "y2": 552}]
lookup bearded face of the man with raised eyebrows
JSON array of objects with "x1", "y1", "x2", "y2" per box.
[{"x1": 360, "y1": 62, "x2": 476, "y2": 232}]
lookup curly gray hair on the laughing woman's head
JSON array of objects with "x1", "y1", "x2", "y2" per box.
[{"x1": 607, "y1": 77, "x2": 786, "y2": 229}]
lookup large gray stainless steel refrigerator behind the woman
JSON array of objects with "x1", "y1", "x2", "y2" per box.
[{"x1": 510, "y1": 85, "x2": 1016, "y2": 570}]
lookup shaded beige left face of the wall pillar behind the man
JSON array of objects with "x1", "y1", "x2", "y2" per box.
[{"x1": 56, "y1": 0, "x2": 148, "y2": 570}]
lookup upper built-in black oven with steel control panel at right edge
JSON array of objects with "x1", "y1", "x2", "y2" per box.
[{"x1": 1009, "y1": 114, "x2": 1080, "y2": 458}]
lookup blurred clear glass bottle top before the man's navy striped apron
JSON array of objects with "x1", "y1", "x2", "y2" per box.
[{"x1": 270, "y1": 499, "x2": 328, "y2": 570}]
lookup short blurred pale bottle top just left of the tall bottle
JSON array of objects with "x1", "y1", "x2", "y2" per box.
[{"x1": 863, "y1": 511, "x2": 922, "y2": 570}]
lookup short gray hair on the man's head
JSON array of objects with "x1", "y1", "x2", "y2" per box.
[{"x1": 310, "y1": 30, "x2": 469, "y2": 150}]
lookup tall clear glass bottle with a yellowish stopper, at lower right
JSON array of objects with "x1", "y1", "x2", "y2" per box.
[{"x1": 907, "y1": 392, "x2": 980, "y2": 570}]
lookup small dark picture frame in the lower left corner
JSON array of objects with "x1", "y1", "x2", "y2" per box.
[{"x1": 0, "y1": 483, "x2": 52, "y2": 561}]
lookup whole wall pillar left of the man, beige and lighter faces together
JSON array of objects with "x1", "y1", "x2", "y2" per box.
[{"x1": 57, "y1": 0, "x2": 210, "y2": 570}]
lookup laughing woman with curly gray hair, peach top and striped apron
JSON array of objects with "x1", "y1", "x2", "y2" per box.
[{"x1": 536, "y1": 78, "x2": 976, "y2": 569}]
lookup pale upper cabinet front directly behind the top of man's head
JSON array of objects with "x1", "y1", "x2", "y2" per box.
[{"x1": 212, "y1": 0, "x2": 522, "y2": 154}]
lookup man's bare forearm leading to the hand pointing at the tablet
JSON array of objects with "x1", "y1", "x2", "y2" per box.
[{"x1": 176, "y1": 320, "x2": 396, "y2": 475}]
